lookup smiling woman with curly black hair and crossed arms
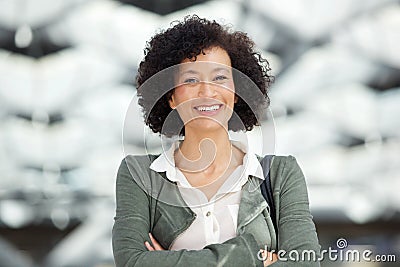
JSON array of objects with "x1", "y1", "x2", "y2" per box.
[{"x1": 113, "y1": 16, "x2": 320, "y2": 266}]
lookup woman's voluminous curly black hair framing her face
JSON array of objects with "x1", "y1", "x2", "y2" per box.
[{"x1": 136, "y1": 15, "x2": 273, "y2": 136}]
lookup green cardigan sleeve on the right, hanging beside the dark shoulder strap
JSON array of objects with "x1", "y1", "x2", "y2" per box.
[{"x1": 270, "y1": 155, "x2": 321, "y2": 267}]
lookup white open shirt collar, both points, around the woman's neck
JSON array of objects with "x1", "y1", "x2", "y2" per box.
[{"x1": 150, "y1": 140, "x2": 265, "y2": 193}]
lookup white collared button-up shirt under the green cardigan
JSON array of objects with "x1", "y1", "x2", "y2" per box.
[{"x1": 150, "y1": 141, "x2": 264, "y2": 250}]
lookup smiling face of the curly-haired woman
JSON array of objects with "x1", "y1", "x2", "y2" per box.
[{"x1": 169, "y1": 47, "x2": 236, "y2": 134}]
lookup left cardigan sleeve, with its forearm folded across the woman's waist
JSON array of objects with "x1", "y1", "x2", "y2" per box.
[{"x1": 112, "y1": 159, "x2": 263, "y2": 267}]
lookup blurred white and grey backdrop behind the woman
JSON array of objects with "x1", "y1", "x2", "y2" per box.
[{"x1": 0, "y1": 0, "x2": 400, "y2": 267}]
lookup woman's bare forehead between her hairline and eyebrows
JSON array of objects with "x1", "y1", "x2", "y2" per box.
[{"x1": 180, "y1": 47, "x2": 232, "y2": 70}]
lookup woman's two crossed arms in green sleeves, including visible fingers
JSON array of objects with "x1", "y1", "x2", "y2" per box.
[{"x1": 112, "y1": 156, "x2": 320, "y2": 267}]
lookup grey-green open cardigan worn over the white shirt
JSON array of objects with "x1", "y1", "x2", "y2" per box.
[{"x1": 112, "y1": 155, "x2": 320, "y2": 267}]
